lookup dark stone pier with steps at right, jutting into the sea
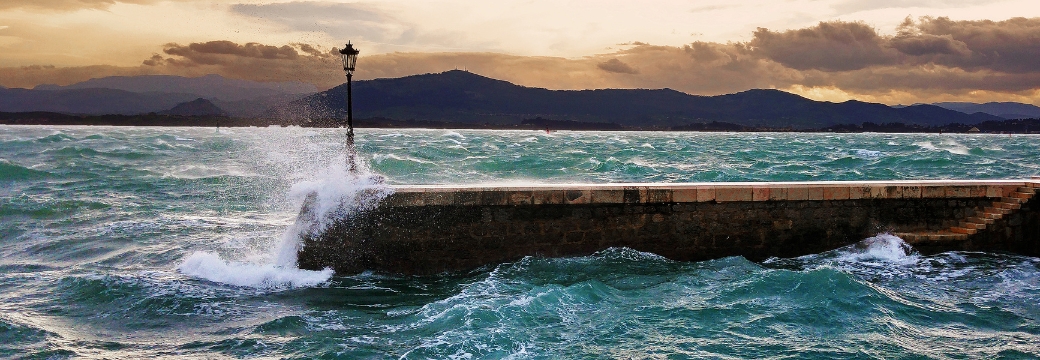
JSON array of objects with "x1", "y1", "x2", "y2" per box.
[{"x1": 298, "y1": 179, "x2": 1040, "y2": 275}]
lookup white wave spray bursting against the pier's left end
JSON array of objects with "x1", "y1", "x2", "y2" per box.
[{"x1": 177, "y1": 152, "x2": 393, "y2": 288}]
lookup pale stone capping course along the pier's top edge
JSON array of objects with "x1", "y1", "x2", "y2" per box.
[{"x1": 386, "y1": 179, "x2": 1040, "y2": 206}]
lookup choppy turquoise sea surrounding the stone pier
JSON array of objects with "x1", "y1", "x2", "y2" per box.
[{"x1": 0, "y1": 126, "x2": 1040, "y2": 359}]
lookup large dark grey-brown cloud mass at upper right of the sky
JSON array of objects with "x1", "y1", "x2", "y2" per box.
[{"x1": 748, "y1": 17, "x2": 1040, "y2": 73}]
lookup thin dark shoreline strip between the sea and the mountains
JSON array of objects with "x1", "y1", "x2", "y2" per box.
[{"x1": 0, "y1": 111, "x2": 1040, "y2": 134}]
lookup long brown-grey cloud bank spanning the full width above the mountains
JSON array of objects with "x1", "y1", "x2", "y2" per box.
[{"x1": 6, "y1": 18, "x2": 1040, "y2": 103}]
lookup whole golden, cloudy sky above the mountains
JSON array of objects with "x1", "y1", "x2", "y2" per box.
[{"x1": 0, "y1": 0, "x2": 1040, "y2": 105}]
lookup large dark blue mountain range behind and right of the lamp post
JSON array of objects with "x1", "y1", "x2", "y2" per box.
[{"x1": 263, "y1": 71, "x2": 1002, "y2": 129}]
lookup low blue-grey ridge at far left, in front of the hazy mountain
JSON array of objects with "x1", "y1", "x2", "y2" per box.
[{"x1": 0, "y1": 88, "x2": 198, "y2": 114}]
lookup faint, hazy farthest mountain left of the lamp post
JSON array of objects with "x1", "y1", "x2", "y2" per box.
[{"x1": 33, "y1": 74, "x2": 318, "y2": 101}]
